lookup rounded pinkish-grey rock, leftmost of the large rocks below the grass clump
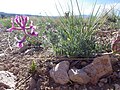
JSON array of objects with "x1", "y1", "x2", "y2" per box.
[{"x1": 50, "y1": 61, "x2": 69, "y2": 84}]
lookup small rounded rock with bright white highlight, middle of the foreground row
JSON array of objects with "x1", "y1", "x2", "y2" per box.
[{"x1": 68, "y1": 69, "x2": 90, "y2": 84}]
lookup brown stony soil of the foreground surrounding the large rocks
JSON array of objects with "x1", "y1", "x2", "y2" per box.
[{"x1": 0, "y1": 31, "x2": 120, "y2": 90}]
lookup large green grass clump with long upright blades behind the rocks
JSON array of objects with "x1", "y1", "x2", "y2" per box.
[{"x1": 42, "y1": 0, "x2": 116, "y2": 57}]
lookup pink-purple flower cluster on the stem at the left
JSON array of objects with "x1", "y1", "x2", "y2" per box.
[{"x1": 7, "y1": 16, "x2": 38, "y2": 48}]
